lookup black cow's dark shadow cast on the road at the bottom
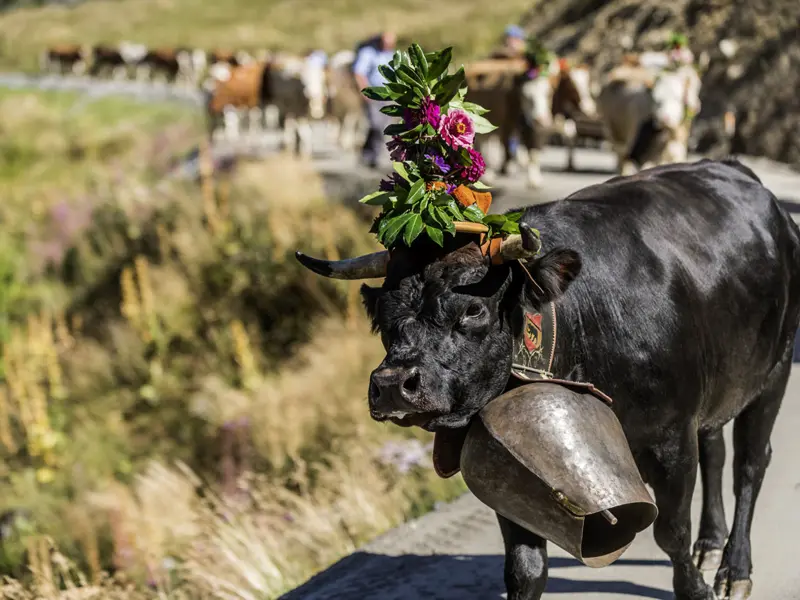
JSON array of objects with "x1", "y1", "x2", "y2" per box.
[{"x1": 281, "y1": 552, "x2": 673, "y2": 600}]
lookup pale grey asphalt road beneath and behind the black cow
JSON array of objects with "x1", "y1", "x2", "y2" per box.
[{"x1": 284, "y1": 148, "x2": 800, "y2": 600}]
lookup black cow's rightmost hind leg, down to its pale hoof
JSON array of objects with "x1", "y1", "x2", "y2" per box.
[{"x1": 714, "y1": 348, "x2": 792, "y2": 600}]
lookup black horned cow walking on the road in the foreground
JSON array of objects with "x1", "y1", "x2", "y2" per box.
[{"x1": 298, "y1": 160, "x2": 800, "y2": 600}]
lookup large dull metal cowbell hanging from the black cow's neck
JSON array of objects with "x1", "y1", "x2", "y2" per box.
[{"x1": 461, "y1": 380, "x2": 658, "y2": 567}]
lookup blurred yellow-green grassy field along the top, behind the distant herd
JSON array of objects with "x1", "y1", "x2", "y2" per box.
[{"x1": 0, "y1": 0, "x2": 535, "y2": 68}]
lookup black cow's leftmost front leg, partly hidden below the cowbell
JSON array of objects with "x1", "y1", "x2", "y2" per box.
[{"x1": 497, "y1": 515, "x2": 547, "y2": 600}]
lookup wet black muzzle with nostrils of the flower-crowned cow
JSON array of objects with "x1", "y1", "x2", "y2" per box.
[{"x1": 369, "y1": 367, "x2": 429, "y2": 421}]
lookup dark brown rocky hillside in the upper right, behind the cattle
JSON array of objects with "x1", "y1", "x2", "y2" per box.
[{"x1": 523, "y1": 0, "x2": 800, "y2": 167}]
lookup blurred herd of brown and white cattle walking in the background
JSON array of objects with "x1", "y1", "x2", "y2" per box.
[{"x1": 41, "y1": 42, "x2": 734, "y2": 187}]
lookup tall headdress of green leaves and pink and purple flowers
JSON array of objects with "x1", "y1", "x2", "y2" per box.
[{"x1": 361, "y1": 44, "x2": 538, "y2": 250}]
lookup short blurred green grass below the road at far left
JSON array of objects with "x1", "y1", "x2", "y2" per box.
[{"x1": 0, "y1": 90, "x2": 202, "y2": 237}]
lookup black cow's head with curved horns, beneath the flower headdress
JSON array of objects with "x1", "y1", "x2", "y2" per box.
[{"x1": 297, "y1": 227, "x2": 581, "y2": 431}]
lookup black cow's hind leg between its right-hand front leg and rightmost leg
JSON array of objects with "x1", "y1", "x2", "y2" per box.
[{"x1": 692, "y1": 430, "x2": 728, "y2": 571}]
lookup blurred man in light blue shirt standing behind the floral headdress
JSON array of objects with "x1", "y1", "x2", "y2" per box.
[{"x1": 353, "y1": 31, "x2": 397, "y2": 168}]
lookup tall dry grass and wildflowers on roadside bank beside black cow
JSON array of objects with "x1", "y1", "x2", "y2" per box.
[{"x1": 0, "y1": 86, "x2": 464, "y2": 600}]
